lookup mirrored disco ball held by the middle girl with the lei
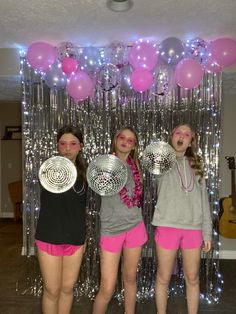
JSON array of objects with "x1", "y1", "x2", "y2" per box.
[{"x1": 87, "y1": 155, "x2": 128, "y2": 196}]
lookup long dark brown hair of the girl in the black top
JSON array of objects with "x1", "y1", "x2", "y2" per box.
[{"x1": 57, "y1": 125, "x2": 87, "y2": 182}]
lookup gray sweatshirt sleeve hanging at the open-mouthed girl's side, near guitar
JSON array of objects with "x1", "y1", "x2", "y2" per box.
[{"x1": 201, "y1": 178, "x2": 212, "y2": 241}]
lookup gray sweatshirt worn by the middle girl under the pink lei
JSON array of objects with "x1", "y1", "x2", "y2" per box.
[{"x1": 100, "y1": 166, "x2": 143, "y2": 235}]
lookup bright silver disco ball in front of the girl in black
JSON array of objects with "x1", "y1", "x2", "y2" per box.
[{"x1": 39, "y1": 156, "x2": 77, "y2": 193}]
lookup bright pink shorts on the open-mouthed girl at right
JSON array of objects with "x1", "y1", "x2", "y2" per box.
[{"x1": 155, "y1": 226, "x2": 203, "y2": 250}]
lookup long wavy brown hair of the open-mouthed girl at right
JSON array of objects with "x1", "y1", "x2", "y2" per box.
[{"x1": 169, "y1": 123, "x2": 204, "y2": 182}]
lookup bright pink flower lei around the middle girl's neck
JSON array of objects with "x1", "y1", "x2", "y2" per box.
[{"x1": 119, "y1": 156, "x2": 142, "y2": 208}]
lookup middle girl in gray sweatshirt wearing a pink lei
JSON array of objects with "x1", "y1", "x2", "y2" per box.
[{"x1": 93, "y1": 127, "x2": 147, "y2": 314}]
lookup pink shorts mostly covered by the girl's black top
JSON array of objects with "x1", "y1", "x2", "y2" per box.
[{"x1": 35, "y1": 240, "x2": 81, "y2": 256}]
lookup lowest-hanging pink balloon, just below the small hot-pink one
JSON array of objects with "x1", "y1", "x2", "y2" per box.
[{"x1": 67, "y1": 71, "x2": 93, "y2": 101}]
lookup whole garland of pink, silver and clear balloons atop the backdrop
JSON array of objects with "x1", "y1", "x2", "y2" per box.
[{"x1": 23, "y1": 37, "x2": 236, "y2": 101}]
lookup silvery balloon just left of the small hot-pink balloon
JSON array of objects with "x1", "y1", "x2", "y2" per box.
[{"x1": 44, "y1": 61, "x2": 67, "y2": 89}]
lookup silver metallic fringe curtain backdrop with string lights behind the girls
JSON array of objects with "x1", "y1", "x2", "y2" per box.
[{"x1": 21, "y1": 57, "x2": 223, "y2": 303}]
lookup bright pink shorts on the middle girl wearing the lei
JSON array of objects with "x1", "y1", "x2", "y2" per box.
[{"x1": 100, "y1": 221, "x2": 148, "y2": 253}]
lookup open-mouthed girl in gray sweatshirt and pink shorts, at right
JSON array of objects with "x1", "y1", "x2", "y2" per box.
[{"x1": 152, "y1": 124, "x2": 212, "y2": 314}]
